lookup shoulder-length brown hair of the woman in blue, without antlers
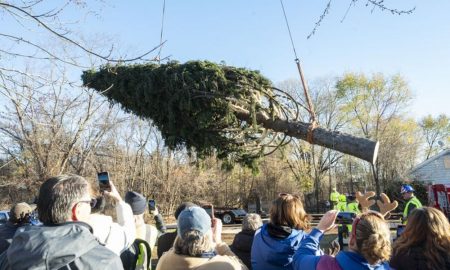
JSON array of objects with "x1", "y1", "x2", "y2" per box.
[{"x1": 270, "y1": 194, "x2": 310, "y2": 230}]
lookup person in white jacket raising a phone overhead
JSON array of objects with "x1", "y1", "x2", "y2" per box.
[{"x1": 88, "y1": 181, "x2": 136, "y2": 255}]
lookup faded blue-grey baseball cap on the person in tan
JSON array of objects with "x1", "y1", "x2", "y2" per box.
[{"x1": 177, "y1": 206, "x2": 211, "y2": 238}]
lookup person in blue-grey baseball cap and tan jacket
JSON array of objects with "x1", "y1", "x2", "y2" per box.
[{"x1": 156, "y1": 206, "x2": 247, "y2": 270}]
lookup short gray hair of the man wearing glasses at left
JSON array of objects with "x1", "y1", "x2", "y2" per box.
[{"x1": 37, "y1": 175, "x2": 89, "y2": 225}]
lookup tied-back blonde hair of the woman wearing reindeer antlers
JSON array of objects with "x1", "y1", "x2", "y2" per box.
[{"x1": 353, "y1": 211, "x2": 392, "y2": 264}]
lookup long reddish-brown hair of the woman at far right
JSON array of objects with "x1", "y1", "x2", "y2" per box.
[{"x1": 394, "y1": 207, "x2": 450, "y2": 269}]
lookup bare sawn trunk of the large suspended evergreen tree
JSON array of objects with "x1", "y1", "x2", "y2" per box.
[{"x1": 233, "y1": 106, "x2": 379, "y2": 164}]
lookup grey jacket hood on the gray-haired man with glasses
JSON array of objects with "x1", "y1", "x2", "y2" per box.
[{"x1": 7, "y1": 222, "x2": 98, "y2": 269}]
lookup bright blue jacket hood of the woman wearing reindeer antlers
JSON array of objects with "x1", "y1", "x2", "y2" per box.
[{"x1": 336, "y1": 251, "x2": 391, "y2": 270}]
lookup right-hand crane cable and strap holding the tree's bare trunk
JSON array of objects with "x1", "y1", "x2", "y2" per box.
[{"x1": 280, "y1": 0, "x2": 318, "y2": 144}]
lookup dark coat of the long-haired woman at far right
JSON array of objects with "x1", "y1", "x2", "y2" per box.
[{"x1": 389, "y1": 246, "x2": 450, "y2": 270}]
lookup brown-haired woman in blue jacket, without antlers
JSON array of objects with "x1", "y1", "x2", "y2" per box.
[{"x1": 251, "y1": 193, "x2": 309, "y2": 270}]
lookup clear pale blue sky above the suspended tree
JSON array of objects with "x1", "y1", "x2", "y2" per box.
[{"x1": 3, "y1": 0, "x2": 450, "y2": 118}]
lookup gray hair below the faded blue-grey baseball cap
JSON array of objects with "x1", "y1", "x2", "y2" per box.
[{"x1": 173, "y1": 230, "x2": 214, "y2": 257}]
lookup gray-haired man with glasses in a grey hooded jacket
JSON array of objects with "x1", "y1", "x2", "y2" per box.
[{"x1": 0, "y1": 175, "x2": 123, "y2": 270}]
